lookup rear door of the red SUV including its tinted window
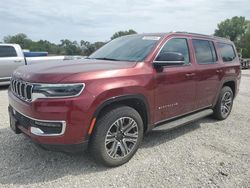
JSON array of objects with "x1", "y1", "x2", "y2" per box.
[{"x1": 192, "y1": 39, "x2": 223, "y2": 109}]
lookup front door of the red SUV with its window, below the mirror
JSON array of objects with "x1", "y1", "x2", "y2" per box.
[{"x1": 155, "y1": 37, "x2": 196, "y2": 122}]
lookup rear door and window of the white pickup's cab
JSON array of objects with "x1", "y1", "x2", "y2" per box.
[{"x1": 0, "y1": 45, "x2": 25, "y2": 81}]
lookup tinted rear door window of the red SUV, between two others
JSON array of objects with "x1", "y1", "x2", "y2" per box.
[{"x1": 193, "y1": 39, "x2": 217, "y2": 64}]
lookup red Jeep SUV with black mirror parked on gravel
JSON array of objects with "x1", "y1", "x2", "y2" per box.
[{"x1": 9, "y1": 32, "x2": 241, "y2": 166}]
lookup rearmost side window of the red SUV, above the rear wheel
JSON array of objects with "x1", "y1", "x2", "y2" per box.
[{"x1": 219, "y1": 43, "x2": 236, "y2": 62}]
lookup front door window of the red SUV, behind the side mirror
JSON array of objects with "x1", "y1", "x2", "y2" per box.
[{"x1": 159, "y1": 38, "x2": 190, "y2": 64}]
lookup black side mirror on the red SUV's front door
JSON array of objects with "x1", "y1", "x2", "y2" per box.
[{"x1": 153, "y1": 52, "x2": 185, "y2": 68}]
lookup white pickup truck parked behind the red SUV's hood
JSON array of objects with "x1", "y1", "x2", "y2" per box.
[{"x1": 0, "y1": 44, "x2": 84, "y2": 86}]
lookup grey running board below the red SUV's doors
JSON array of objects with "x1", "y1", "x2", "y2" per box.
[{"x1": 153, "y1": 109, "x2": 213, "y2": 131}]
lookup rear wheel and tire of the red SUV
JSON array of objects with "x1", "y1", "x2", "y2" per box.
[{"x1": 214, "y1": 86, "x2": 234, "y2": 120}]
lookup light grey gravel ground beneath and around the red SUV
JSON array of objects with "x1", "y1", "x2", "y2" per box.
[{"x1": 0, "y1": 70, "x2": 250, "y2": 188}]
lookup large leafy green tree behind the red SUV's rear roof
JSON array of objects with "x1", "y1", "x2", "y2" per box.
[{"x1": 214, "y1": 16, "x2": 248, "y2": 47}]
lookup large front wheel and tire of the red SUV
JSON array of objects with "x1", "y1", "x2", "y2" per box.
[{"x1": 89, "y1": 106, "x2": 143, "y2": 167}]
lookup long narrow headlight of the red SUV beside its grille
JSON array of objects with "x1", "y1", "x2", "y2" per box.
[{"x1": 32, "y1": 83, "x2": 85, "y2": 100}]
